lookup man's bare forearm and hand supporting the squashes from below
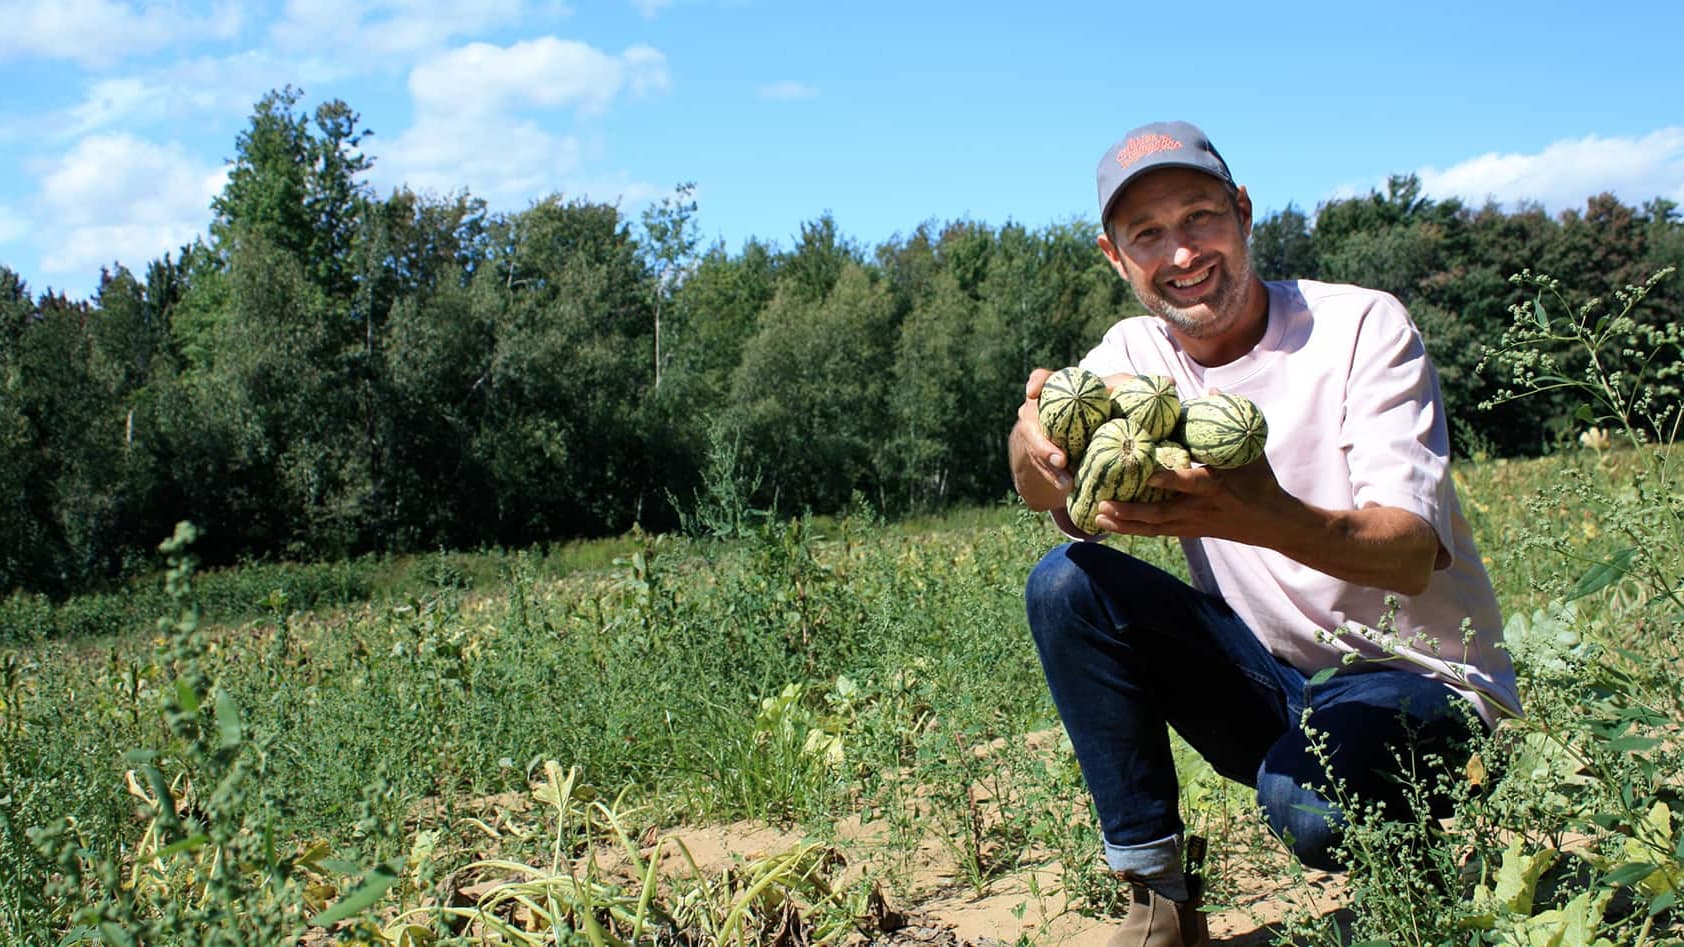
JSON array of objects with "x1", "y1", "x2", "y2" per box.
[{"x1": 1096, "y1": 457, "x2": 1442, "y2": 595}]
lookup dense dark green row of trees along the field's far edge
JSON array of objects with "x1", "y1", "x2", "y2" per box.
[{"x1": 0, "y1": 89, "x2": 1684, "y2": 593}]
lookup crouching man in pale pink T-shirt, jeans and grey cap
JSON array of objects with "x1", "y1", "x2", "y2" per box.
[{"x1": 1010, "y1": 121, "x2": 1519, "y2": 947}]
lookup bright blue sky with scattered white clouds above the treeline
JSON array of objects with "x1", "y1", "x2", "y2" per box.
[{"x1": 0, "y1": 0, "x2": 1684, "y2": 297}]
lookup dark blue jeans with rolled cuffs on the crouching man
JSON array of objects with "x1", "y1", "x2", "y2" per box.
[{"x1": 1026, "y1": 543, "x2": 1477, "y2": 871}]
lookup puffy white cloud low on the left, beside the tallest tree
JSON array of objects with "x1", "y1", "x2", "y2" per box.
[{"x1": 39, "y1": 135, "x2": 227, "y2": 280}]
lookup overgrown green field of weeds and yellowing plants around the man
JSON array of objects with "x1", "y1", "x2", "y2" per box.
[{"x1": 0, "y1": 438, "x2": 1684, "y2": 945}]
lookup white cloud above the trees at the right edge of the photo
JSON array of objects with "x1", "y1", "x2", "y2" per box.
[{"x1": 1418, "y1": 126, "x2": 1684, "y2": 212}]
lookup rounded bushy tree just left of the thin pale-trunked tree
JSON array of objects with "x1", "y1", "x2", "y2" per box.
[{"x1": 473, "y1": 199, "x2": 658, "y2": 543}]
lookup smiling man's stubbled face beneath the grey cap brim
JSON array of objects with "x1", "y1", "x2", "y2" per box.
[{"x1": 1100, "y1": 169, "x2": 1253, "y2": 339}]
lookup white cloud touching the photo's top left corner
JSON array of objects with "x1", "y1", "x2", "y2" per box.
[{"x1": 0, "y1": 0, "x2": 241, "y2": 67}]
